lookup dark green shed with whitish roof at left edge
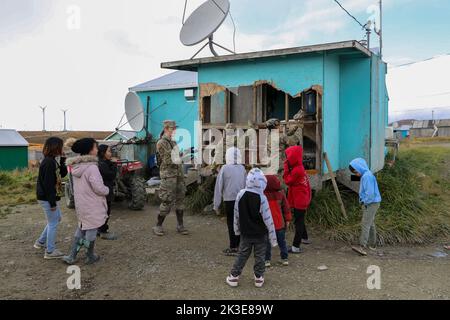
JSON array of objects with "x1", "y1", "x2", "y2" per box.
[{"x1": 0, "y1": 129, "x2": 28, "y2": 170}]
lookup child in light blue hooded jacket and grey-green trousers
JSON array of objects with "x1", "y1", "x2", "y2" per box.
[{"x1": 349, "y1": 158, "x2": 381, "y2": 256}]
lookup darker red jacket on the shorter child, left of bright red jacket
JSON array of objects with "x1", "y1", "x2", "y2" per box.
[{"x1": 264, "y1": 176, "x2": 292, "y2": 230}]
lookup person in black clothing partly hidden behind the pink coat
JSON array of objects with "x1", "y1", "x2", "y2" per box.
[{"x1": 98, "y1": 144, "x2": 117, "y2": 240}]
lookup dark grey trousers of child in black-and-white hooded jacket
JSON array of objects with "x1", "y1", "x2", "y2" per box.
[{"x1": 231, "y1": 235, "x2": 269, "y2": 278}]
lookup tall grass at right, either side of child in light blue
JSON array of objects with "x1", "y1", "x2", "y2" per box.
[{"x1": 308, "y1": 143, "x2": 450, "y2": 244}]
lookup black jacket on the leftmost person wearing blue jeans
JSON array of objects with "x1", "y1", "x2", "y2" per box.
[{"x1": 36, "y1": 157, "x2": 67, "y2": 208}]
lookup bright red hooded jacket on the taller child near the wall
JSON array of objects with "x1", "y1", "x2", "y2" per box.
[{"x1": 283, "y1": 146, "x2": 311, "y2": 210}]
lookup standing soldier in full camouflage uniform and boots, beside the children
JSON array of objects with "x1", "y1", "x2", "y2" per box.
[{"x1": 153, "y1": 120, "x2": 189, "y2": 236}]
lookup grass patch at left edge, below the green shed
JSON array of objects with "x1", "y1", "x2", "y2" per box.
[{"x1": 0, "y1": 169, "x2": 38, "y2": 217}]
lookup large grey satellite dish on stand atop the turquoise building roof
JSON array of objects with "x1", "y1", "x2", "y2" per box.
[{"x1": 180, "y1": 0, "x2": 235, "y2": 59}]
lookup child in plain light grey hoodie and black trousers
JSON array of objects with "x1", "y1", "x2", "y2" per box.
[{"x1": 214, "y1": 147, "x2": 247, "y2": 256}]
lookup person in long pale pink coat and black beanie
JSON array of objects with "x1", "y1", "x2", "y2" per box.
[{"x1": 63, "y1": 138, "x2": 109, "y2": 264}]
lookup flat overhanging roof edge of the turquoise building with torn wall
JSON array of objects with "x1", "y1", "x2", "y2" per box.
[{"x1": 161, "y1": 40, "x2": 372, "y2": 71}]
